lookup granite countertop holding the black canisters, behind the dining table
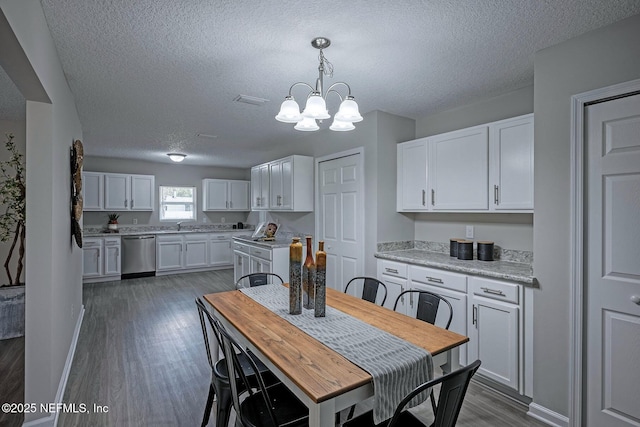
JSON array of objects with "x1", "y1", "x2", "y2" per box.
[{"x1": 375, "y1": 248, "x2": 537, "y2": 287}]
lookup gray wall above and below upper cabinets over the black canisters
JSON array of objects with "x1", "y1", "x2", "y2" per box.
[{"x1": 407, "y1": 86, "x2": 537, "y2": 251}]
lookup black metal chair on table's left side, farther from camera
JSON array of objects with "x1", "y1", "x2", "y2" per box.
[{"x1": 196, "y1": 298, "x2": 278, "y2": 427}]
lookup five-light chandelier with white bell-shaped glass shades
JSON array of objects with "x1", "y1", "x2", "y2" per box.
[{"x1": 276, "y1": 37, "x2": 362, "y2": 132}]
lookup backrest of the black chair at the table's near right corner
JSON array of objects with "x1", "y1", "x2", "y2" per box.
[{"x1": 387, "y1": 360, "x2": 481, "y2": 427}]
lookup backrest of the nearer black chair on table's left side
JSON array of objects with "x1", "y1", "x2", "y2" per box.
[{"x1": 213, "y1": 318, "x2": 279, "y2": 426}]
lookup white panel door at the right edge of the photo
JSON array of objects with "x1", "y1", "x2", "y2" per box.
[{"x1": 584, "y1": 95, "x2": 640, "y2": 427}]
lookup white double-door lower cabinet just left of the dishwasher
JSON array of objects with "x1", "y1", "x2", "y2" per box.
[{"x1": 82, "y1": 237, "x2": 121, "y2": 283}]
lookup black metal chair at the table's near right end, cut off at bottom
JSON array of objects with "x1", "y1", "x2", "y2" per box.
[{"x1": 343, "y1": 360, "x2": 481, "y2": 427}]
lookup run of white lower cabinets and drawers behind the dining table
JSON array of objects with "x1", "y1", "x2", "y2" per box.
[{"x1": 377, "y1": 259, "x2": 533, "y2": 397}]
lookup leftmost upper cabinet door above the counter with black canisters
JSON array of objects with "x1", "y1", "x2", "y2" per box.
[{"x1": 396, "y1": 138, "x2": 429, "y2": 212}]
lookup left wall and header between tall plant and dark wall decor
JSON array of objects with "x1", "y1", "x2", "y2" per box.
[{"x1": 0, "y1": 0, "x2": 82, "y2": 421}]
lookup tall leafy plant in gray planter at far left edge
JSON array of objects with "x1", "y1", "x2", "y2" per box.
[{"x1": 0, "y1": 133, "x2": 26, "y2": 339}]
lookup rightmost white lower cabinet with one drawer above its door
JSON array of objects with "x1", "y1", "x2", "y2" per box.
[{"x1": 469, "y1": 277, "x2": 522, "y2": 391}]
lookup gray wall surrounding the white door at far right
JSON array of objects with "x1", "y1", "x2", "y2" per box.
[{"x1": 533, "y1": 15, "x2": 640, "y2": 415}]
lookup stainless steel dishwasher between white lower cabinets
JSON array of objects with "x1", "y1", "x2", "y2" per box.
[{"x1": 122, "y1": 234, "x2": 156, "y2": 279}]
